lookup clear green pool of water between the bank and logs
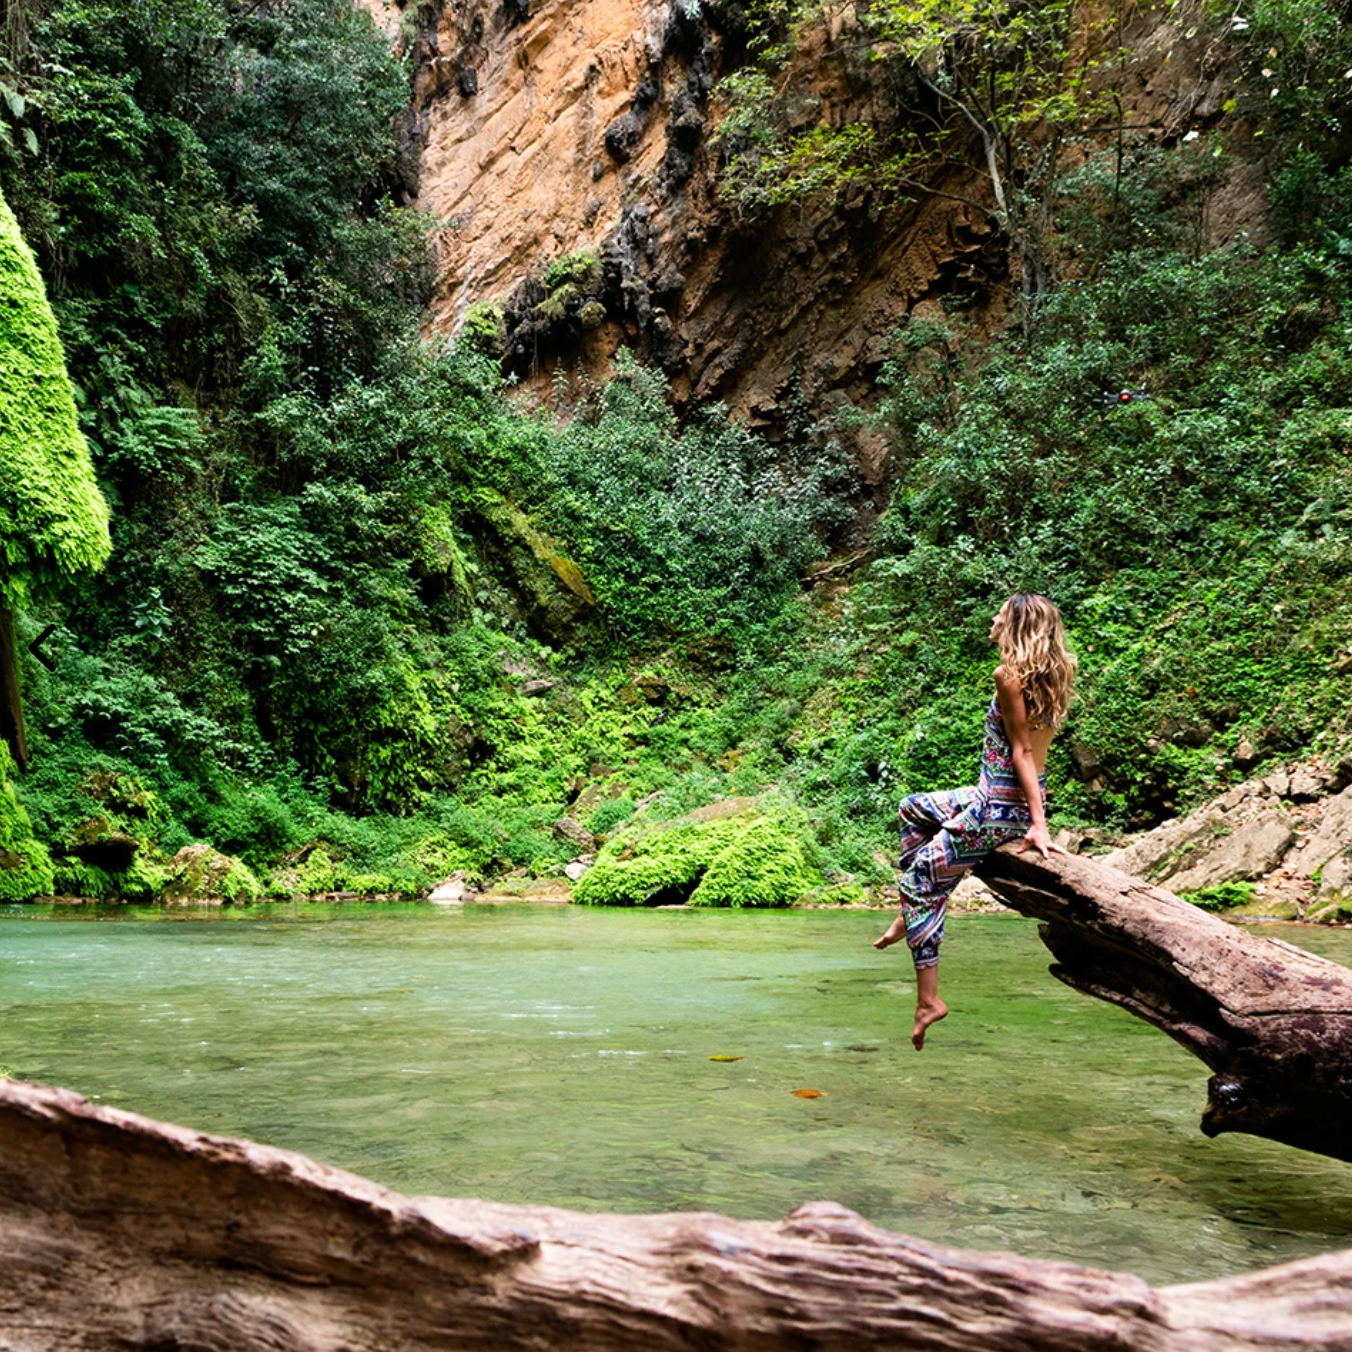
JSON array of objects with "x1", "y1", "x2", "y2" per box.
[{"x1": 0, "y1": 906, "x2": 1352, "y2": 1282}]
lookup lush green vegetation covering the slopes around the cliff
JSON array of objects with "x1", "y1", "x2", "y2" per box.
[{"x1": 0, "y1": 0, "x2": 1352, "y2": 904}]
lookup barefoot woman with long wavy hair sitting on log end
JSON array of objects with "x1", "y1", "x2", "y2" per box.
[{"x1": 873, "y1": 592, "x2": 1075, "y2": 1051}]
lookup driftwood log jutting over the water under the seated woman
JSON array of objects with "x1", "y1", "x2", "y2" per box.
[{"x1": 977, "y1": 846, "x2": 1352, "y2": 1160}]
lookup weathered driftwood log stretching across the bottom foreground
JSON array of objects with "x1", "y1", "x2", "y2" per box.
[{"x1": 0, "y1": 1082, "x2": 1352, "y2": 1352}]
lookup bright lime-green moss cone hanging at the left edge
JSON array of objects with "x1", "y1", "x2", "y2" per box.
[{"x1": 0, "y1": 183, "x2": 111, "y2": 606}]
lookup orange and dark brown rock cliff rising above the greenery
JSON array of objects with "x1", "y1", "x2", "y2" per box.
[{"x1": 360, "y1": 0, "x2": 1263, "y2": 459}]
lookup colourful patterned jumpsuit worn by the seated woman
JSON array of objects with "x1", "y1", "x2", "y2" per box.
[{"x1": 898, "y1": 698, "x2": 1046, "y2": 967}]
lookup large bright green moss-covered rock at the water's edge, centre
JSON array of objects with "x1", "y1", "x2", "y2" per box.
[{"x1": 573, "y1": 813, "x2": 819, "y2": 906}]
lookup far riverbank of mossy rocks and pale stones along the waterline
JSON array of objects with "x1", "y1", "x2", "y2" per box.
[{"x1": 11, "y1": 752, "x2": 1352, "y2": 925}]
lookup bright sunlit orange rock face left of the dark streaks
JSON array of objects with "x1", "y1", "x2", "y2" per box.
[{"x1": 366, "y1": 0, "x2": 667, "y2": 321}]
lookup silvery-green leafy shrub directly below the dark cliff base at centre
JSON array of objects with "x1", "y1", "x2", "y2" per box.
[{"x1": 534, "y1": 350, "x2": 846, "y2": 646}]
